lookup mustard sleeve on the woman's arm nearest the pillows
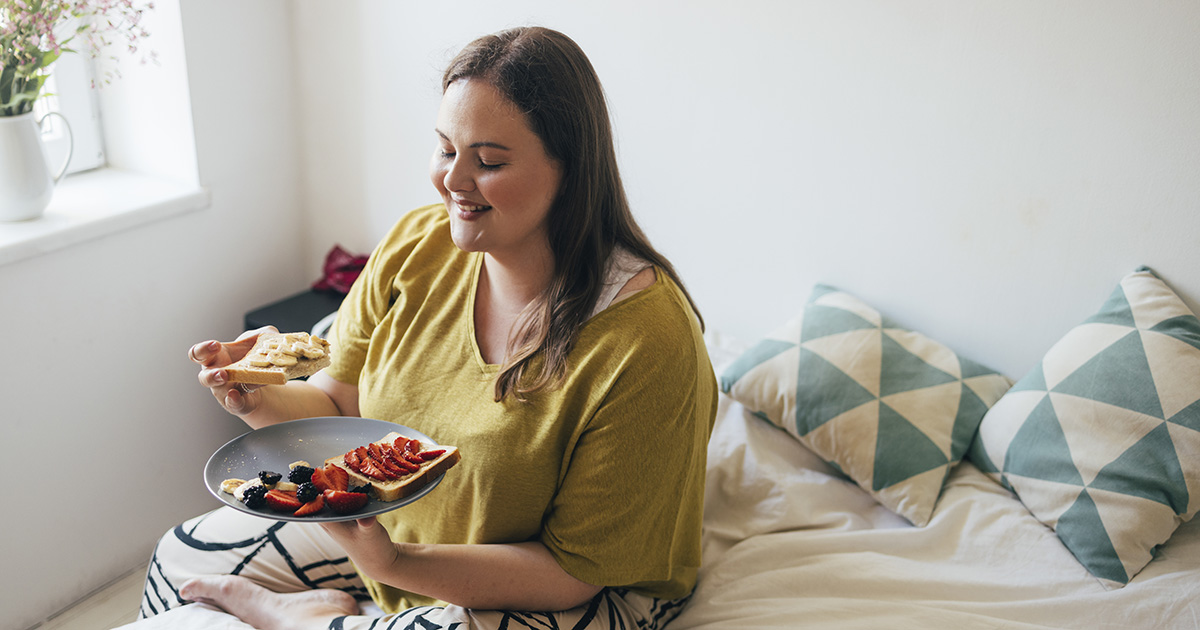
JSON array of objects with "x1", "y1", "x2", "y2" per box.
[{"x1": 541, "y1": 286, "x2": 716, "y2": 598}]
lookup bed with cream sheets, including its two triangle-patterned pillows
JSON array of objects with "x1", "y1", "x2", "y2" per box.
[{"x1": 119, "y1": 269, "x2": 1200, "y2": 630}]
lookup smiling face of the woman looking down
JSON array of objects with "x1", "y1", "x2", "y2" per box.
[{"x1": 430, "y1": 79, "x2": 562, "y2": 259}]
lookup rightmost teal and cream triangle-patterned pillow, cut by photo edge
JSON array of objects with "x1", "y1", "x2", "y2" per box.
[{"x1": 968, "y1": 268, "x2": 1200, "y2": 588}]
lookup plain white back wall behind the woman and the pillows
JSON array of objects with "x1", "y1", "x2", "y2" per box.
[{"x1": 296, "y1": 0, "x2": 1200, "y2": 377}]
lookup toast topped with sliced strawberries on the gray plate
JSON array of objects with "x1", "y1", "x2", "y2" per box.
[{"x1": 325, "y1": 431, "x2": 462, "y2": 502}]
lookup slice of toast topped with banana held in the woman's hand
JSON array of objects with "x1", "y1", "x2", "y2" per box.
[{"x1": 224, "y1": 332, "x2": 331, "y2": 385}]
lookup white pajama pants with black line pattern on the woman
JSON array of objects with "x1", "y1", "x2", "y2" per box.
[{"x1": 133, "y1": 508, "x2": 685, "y2": 630}]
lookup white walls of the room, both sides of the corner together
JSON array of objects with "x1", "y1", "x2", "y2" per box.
[{"x1": 9, "y1": 0, "x2": 1200, "y2": 629}]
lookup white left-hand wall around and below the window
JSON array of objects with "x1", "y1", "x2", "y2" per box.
[{"x1": 0, "y1": 0, "x2": 309, "y2": 630}]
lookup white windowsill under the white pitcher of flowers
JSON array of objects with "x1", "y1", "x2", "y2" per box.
[{"x1": 0, "y1": 168, "x2": 211, "y2": 265}]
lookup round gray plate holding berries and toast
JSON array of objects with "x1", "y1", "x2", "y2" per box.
[{"x1": 204, "y1": 416, "x2": 445, "y2": 523}]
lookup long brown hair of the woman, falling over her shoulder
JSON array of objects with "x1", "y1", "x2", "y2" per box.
[{"x1": 442, "y1": 26, "x2": 703, "y2": 401}]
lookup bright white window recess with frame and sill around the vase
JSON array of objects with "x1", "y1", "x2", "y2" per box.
[{"x1": 0, "y1": 0, "x2": 211, "y2": 266}]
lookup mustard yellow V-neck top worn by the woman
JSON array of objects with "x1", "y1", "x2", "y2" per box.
[{"x1": 326, "y1": 204, "x2": 716, "y2": 612}]
